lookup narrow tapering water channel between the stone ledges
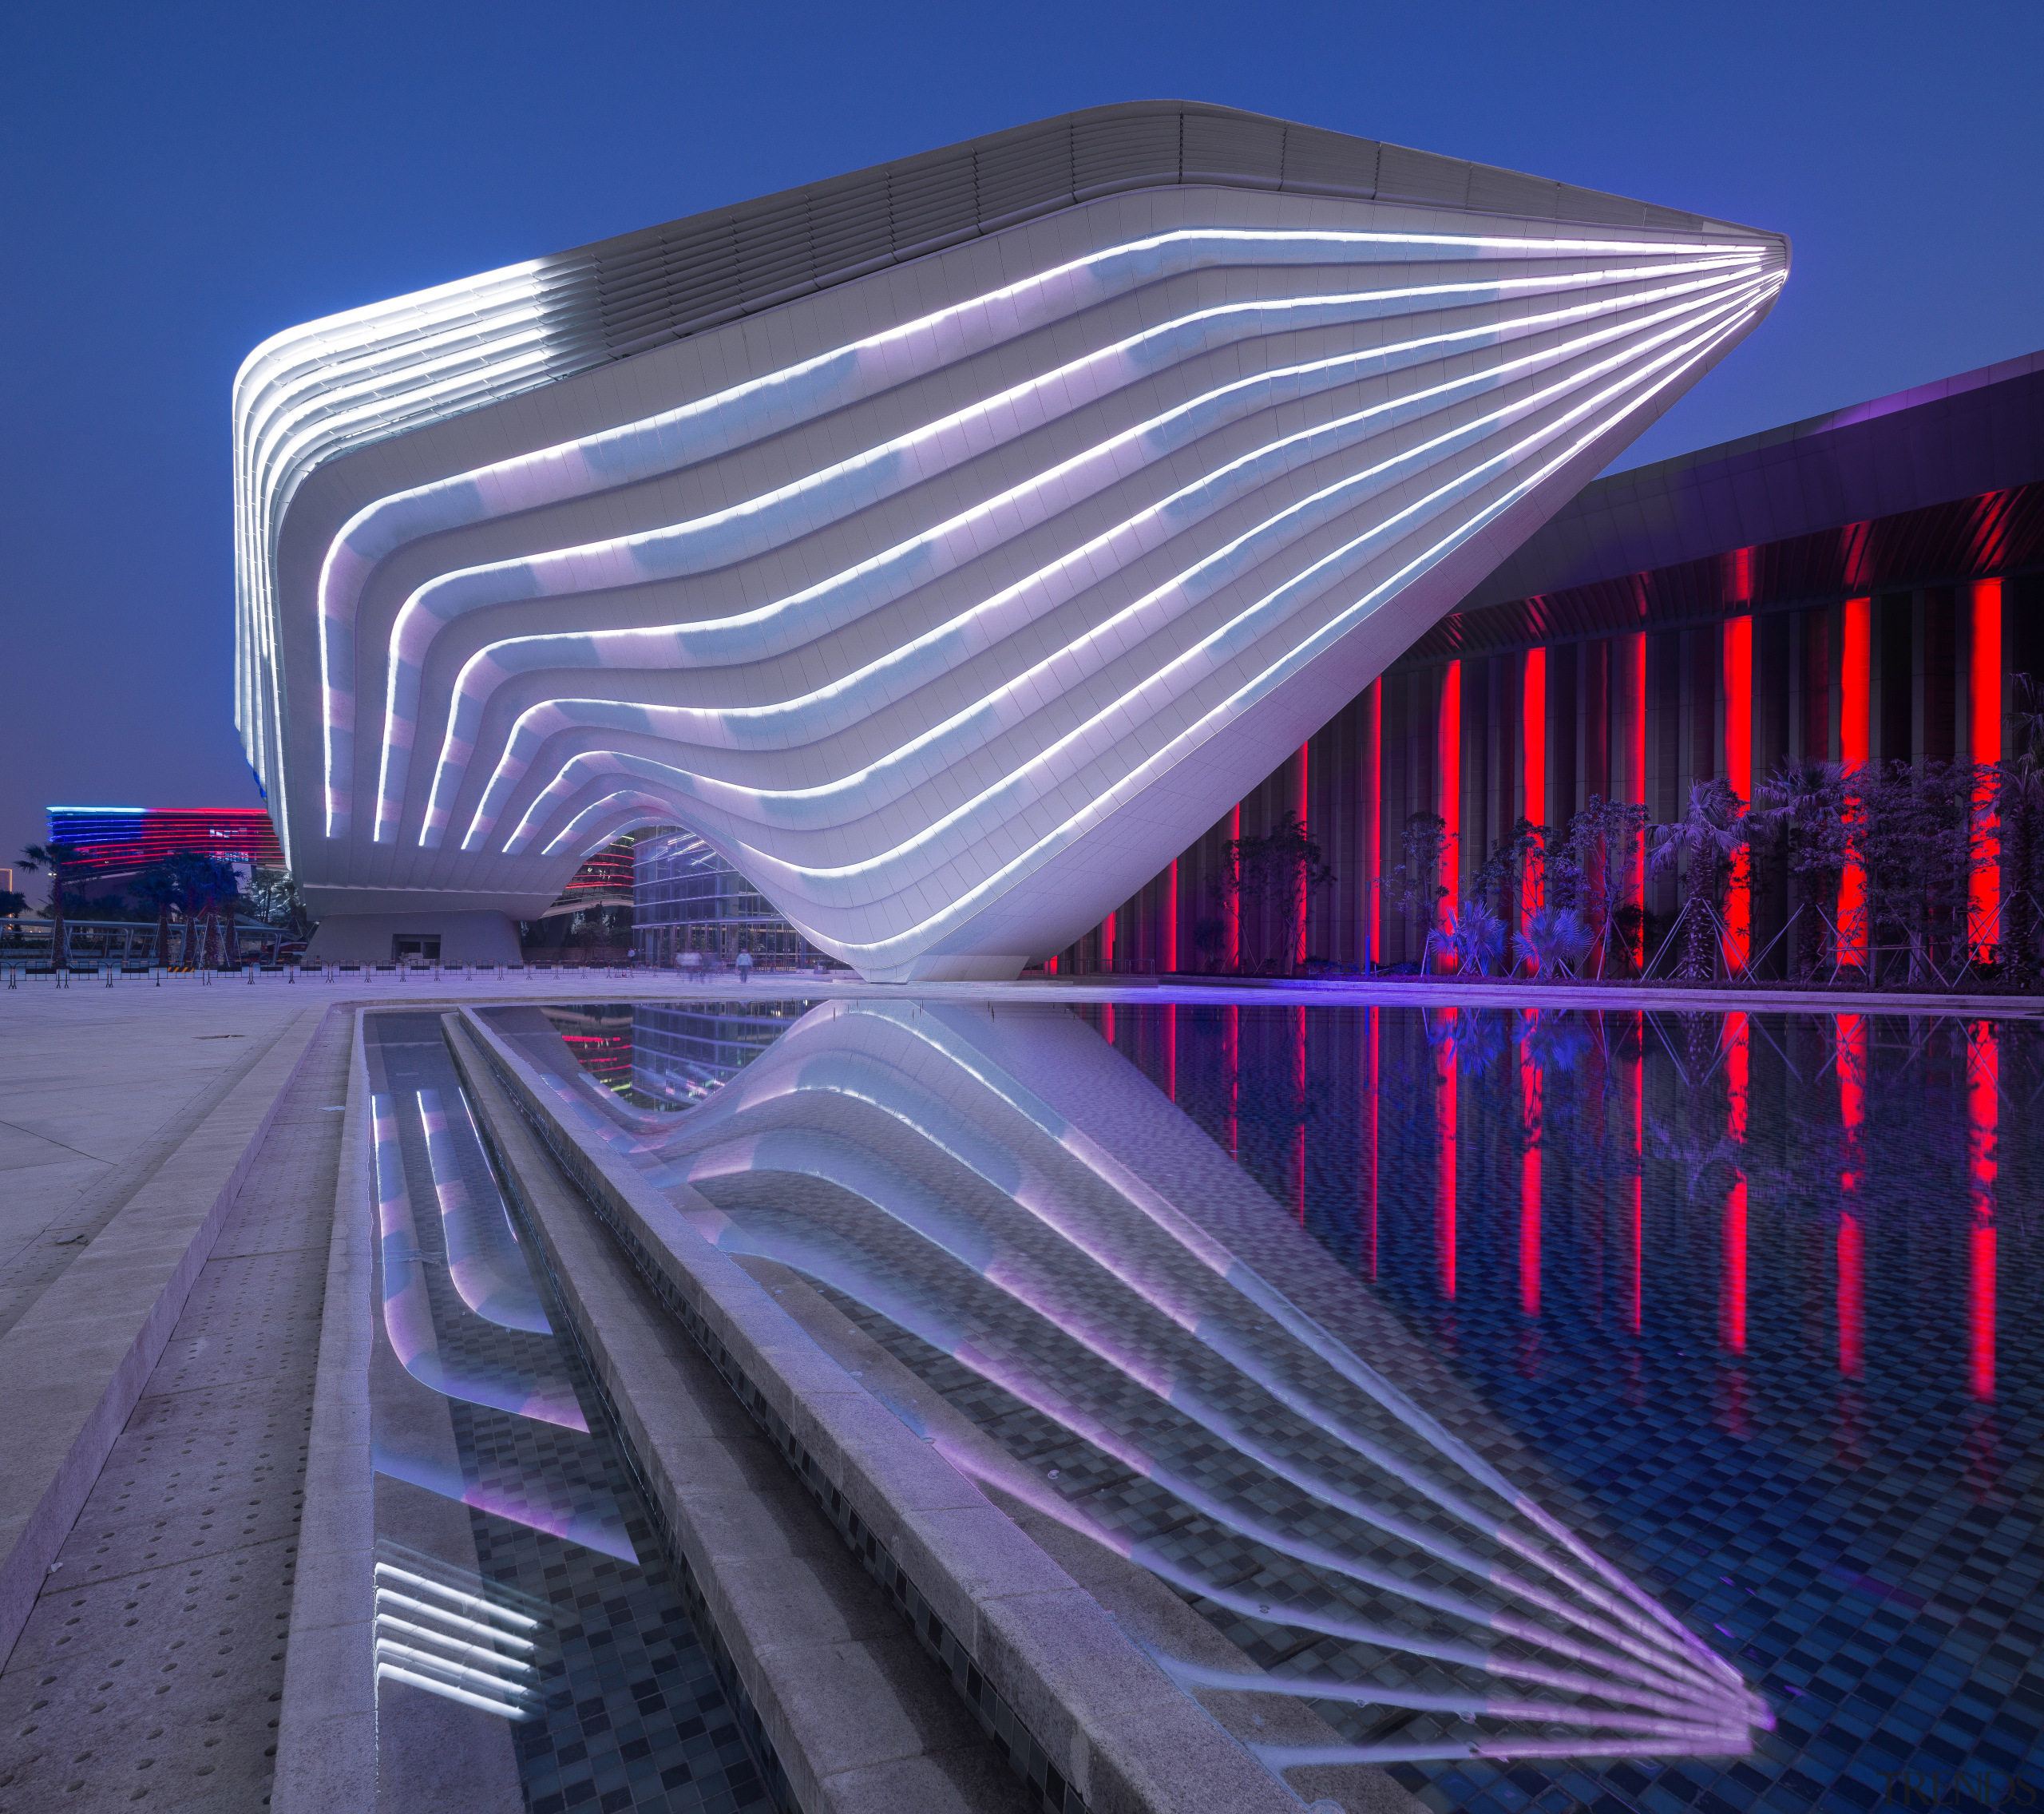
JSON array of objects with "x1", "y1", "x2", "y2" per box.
[{"x1": 364, "y1": 1009, "x2": 782, "y2": 1814}]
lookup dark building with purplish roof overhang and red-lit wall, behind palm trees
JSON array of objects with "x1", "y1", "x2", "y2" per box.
[{"x1": 1057, "y1": 354, "x2": 2044, "y2": 976}]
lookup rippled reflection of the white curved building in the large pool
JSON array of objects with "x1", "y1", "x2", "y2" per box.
[{"x1": 515, "y1": 1003, "x2": 1762, "y2": 1769}]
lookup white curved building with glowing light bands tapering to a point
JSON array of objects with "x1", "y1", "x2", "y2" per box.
[{"x1": 235, "y1": 102, "x2": 1788, "y2": 980}]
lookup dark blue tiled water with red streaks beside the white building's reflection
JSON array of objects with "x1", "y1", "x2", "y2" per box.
[{"x1": 1075, "y1": 1007, "x2": 2044, "y2": 1814}]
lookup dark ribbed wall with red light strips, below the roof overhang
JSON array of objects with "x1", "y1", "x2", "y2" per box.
[{"x1": 1055, "y1": 525, "x2": 2044, "y2": 974}]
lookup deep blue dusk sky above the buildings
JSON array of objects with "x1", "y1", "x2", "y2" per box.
[{"x1": 0, "y1": 0, "x2": 2044, "y2": 878}]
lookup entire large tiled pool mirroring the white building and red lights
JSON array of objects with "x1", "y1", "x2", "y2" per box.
[{"x1": 493, "y1": 999, "x2": 2044, "y2": 1810}]
